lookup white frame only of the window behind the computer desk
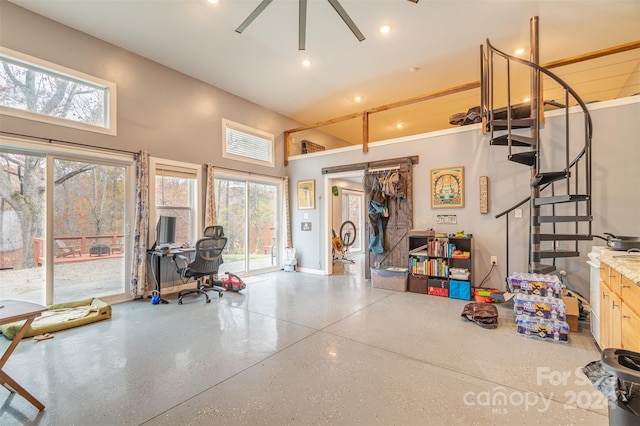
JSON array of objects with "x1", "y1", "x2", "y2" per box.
[{"x1": 147, "y1": 157, "x2": 204, "y2": 247}]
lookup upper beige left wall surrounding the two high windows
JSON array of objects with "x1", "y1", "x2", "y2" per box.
[{"x1": 0, "y1": 0, "x2": 300, "y2": 176}]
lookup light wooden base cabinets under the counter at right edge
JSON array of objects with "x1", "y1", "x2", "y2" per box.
[{"x1": 600, "y1": 263, "x2": 640, "y2": 352}]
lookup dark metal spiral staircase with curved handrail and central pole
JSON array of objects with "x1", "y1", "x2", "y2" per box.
[{"x1": 481, "y1": 17, "x2": 593, "y2": 273}]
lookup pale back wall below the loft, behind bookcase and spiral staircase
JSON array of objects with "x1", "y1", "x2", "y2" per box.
[{"x1": 287, "y1": 97, "x2": 640, "y2": 297}]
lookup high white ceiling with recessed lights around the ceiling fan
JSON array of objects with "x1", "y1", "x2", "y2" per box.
[{"x1": 11, "y1": 0, "x2": 640, "y2": 130}]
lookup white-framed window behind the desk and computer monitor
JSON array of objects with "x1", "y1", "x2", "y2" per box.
[{"x1": 149, "y1": 159, "x2": 201, "y2": 244}]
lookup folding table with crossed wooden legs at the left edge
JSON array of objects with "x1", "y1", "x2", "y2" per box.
[{"x1": 0, "y1": 300, "x2": 47, "y2": 411}]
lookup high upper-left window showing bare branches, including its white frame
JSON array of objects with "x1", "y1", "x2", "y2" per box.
[{"x1": 0, "y1": 48, "x2": 116, "y2": 134}]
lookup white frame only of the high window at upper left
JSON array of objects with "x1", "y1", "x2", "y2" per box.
[{"x1": 0, "y1": 46, "x2": 117, "y2": 136}]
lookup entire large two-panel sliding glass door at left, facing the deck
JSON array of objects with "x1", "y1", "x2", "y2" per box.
[{"x1": 0, "y1": 141, "x2": 131, "y2": 305}]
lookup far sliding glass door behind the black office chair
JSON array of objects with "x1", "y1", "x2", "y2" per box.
[{"x1": 215, "y1": 175, "x2": 282, "y2": 274}]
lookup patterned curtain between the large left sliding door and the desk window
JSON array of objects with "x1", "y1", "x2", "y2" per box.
[{"x1": 131, "y1": 151, "x2": 149, "y2": 298}]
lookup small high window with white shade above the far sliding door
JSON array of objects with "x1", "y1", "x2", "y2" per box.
[{"x1": 222, "y1": 119, "x2": 274, "y2": 167}]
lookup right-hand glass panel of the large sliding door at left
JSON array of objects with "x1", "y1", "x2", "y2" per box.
[{"x1": 52, "y1": 158, "x2": 126, "y2": 303}]
